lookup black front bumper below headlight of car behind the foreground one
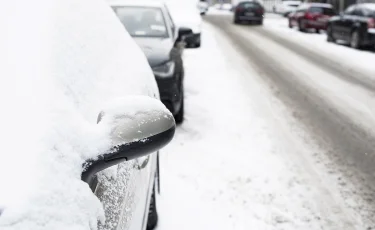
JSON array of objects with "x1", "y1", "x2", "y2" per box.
[{"x1": 155, "y1": 76, "x2": 182, "y2": 115}]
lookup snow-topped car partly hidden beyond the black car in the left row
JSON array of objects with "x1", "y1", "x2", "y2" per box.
[{"x1": 167, "y1": 1, "x2": 202, "y2": 48}]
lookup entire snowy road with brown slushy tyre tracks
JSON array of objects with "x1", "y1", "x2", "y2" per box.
[{"x1": 158, "y1": 14, "x2": 375, "y2": 230}]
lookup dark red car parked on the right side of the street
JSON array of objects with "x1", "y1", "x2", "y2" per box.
[{"x1": 289, "y1": 3, "x2": 336, "y2": 33}]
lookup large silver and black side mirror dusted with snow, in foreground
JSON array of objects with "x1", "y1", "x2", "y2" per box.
[{"x1": 81, "y1": 96, "x2": 176, "y2": 185}]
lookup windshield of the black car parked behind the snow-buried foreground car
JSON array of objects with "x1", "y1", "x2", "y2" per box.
[{"x1": 112, "y1": 6, "x2": 169, "y2": 37}]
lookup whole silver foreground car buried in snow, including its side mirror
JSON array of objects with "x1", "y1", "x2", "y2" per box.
[{"x1": 0, "y1": 0, "x2": 175, "y2": 230}]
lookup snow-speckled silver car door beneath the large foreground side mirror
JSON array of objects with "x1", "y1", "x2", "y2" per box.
[{"x1": 94, "y1": 131, "x2": 156, "y2": 230}]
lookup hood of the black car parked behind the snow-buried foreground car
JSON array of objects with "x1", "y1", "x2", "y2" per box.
[{"x1": 134, "y1": 37, "x2": 174, "y2": 67}]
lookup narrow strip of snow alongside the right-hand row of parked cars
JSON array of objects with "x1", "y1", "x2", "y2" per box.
[{"x1": 264, "y1": 14, "x2": 375, "y2": 76}]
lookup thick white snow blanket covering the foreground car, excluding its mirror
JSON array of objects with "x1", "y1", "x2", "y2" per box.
[{"x1": 0, "y1": 0, "x2": 157, "y2": 230}]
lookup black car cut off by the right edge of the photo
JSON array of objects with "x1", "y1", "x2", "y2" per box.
[{"x1": 327, "y1": 3, "x2": 375, "y2": 49}]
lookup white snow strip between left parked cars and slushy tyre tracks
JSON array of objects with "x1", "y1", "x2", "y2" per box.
[{"x1": 158, "y1": 24, "x2": 363, "y2": 230}]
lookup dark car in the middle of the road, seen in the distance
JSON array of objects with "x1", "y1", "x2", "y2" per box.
[{"x1": 233, "y1": 1, "x2": 264, "y2": 25}]
